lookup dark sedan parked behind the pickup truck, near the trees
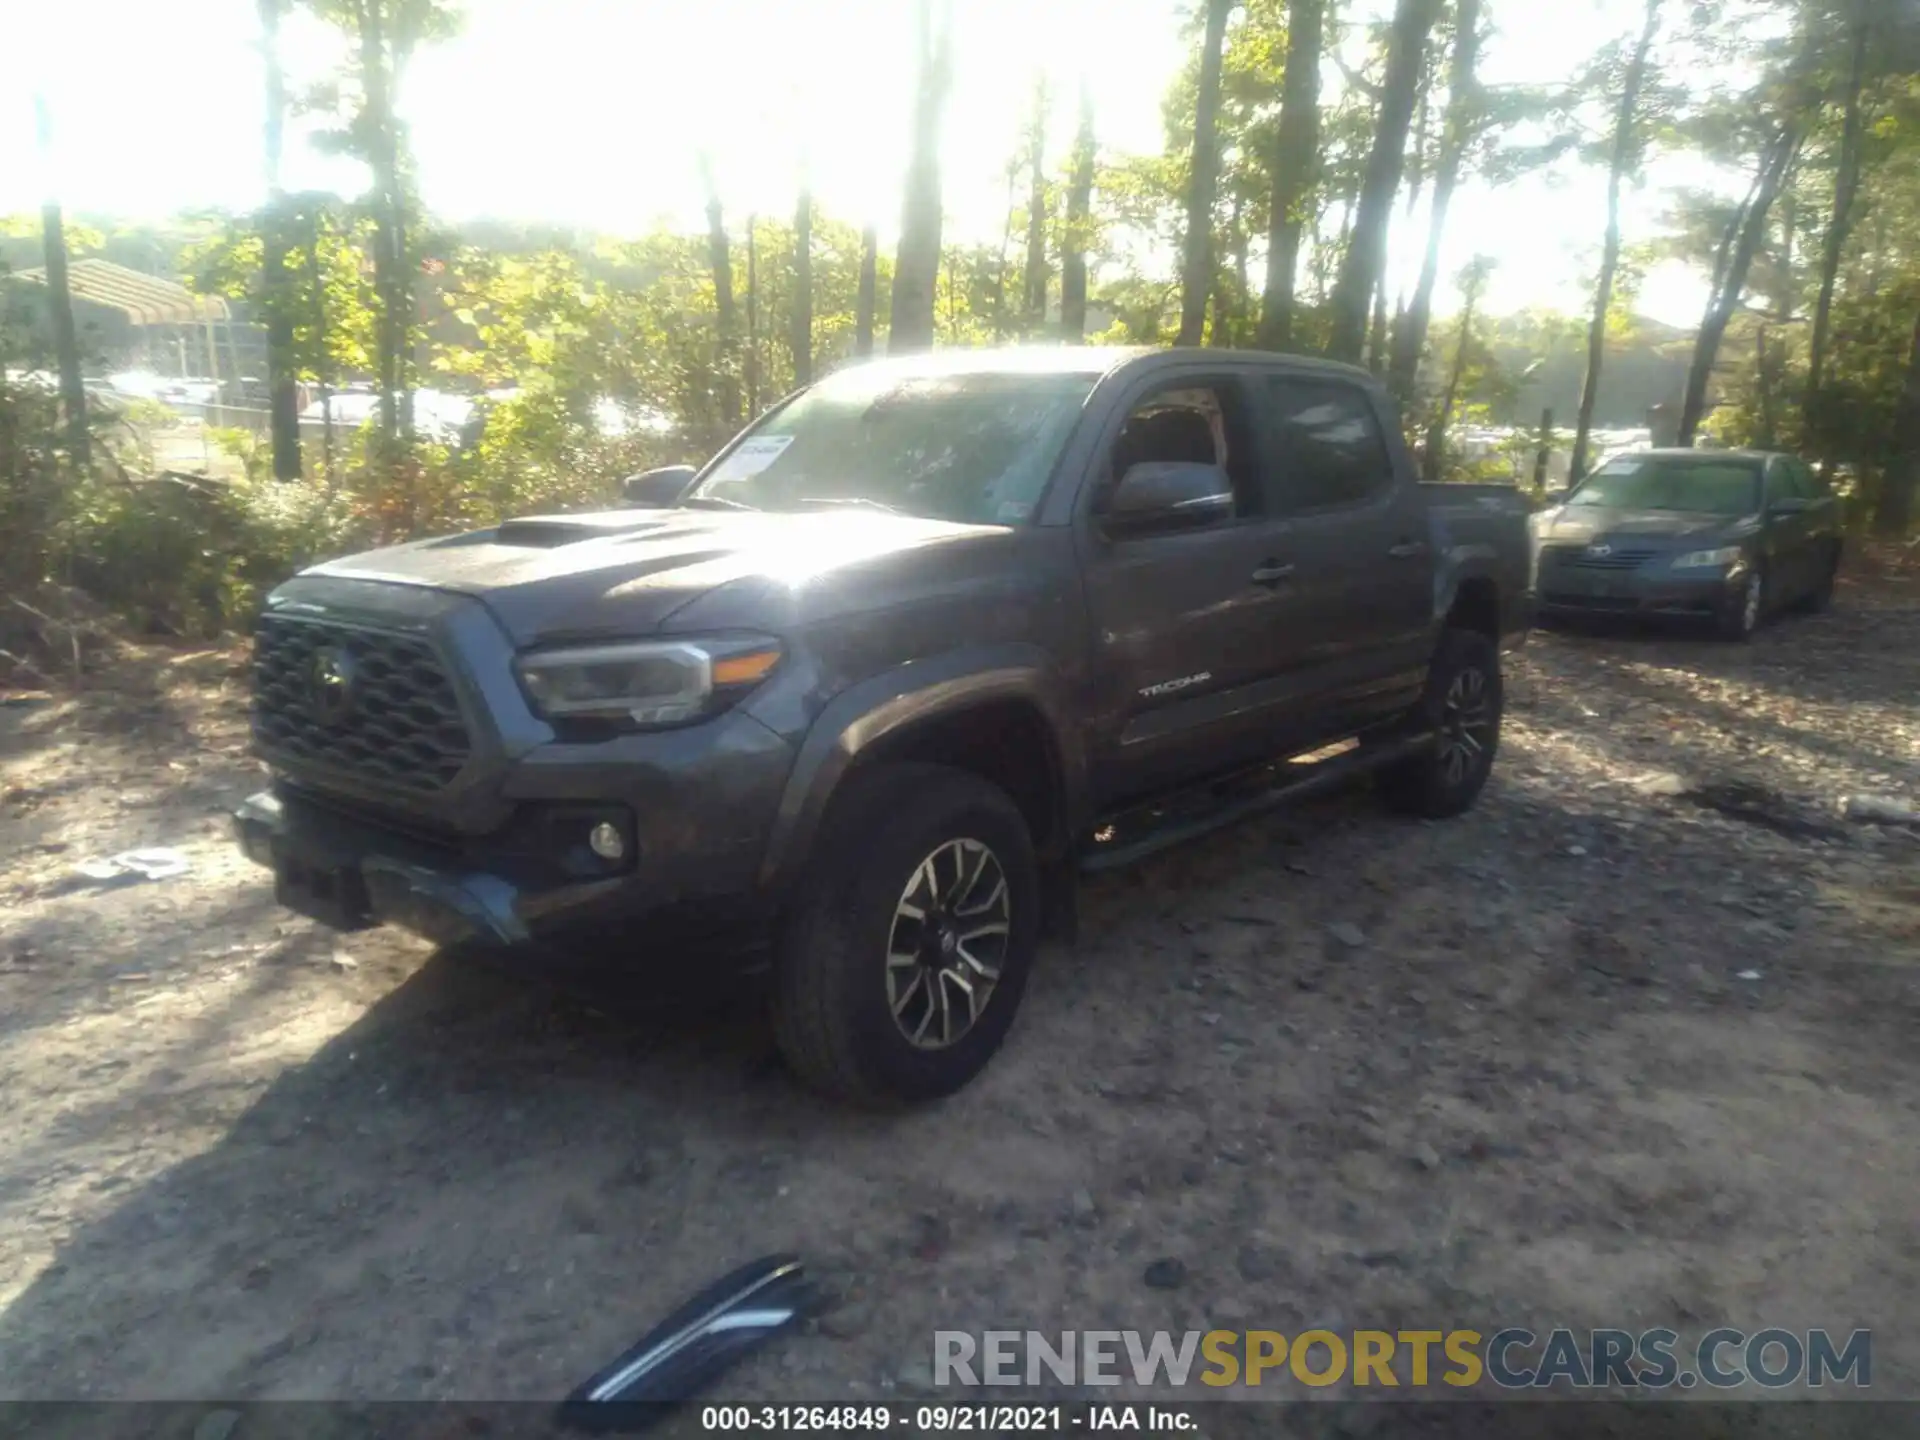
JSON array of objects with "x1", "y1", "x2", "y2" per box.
[{"x1": 1534, "y1": 449, "x2": 1841, "y2": 639}]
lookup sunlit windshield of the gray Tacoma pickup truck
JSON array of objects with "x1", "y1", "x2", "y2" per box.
[{"x1": 687, "y1": 367, "x2": 1094, "y2": 524}]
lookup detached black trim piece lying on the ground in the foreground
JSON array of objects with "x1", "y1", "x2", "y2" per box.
[{"x1": 559, "y1": 1256, "x2": 814, "y2": 1432}]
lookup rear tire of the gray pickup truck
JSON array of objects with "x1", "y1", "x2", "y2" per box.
[{"x1": 1379, "y1": 630, "x2": 1503, "y2": 820}]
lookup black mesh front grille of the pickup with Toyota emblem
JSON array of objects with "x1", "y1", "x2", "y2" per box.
[{"x1": 253, "y1": 614, "x2": 472, "y2": 793}]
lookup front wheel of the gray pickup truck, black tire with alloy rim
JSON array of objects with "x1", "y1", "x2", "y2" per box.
[{"x1": 774, "y1": 764, "x2": 1041, "y2": 1106}]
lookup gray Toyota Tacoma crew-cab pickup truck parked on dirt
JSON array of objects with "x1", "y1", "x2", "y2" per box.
[{"x1": 236, "y1": 348, "x2": 1530, "y2": 1102}]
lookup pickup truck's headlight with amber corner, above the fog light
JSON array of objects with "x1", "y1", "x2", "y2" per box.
[{"x1": 516, "y1": 636, "x2": 780, "y2": 730}]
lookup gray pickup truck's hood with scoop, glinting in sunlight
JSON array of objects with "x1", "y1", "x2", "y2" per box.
[{"x1": 303, "y1": 509, "x2": 1012, "y2": 645}]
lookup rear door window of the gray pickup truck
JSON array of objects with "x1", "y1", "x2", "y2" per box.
[{"x1": 1263, "y1": 374, "x2": 1394, "y2": 515}]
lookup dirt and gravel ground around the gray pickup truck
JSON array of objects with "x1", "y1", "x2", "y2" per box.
[{"x1": 0, "y1": 556, "x2": 1920, "y2": 1400}]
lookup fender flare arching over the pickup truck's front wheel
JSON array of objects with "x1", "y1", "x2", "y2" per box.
[{"x1": 760, "y1": 645, "x2": 1089, "y2": 893}]
